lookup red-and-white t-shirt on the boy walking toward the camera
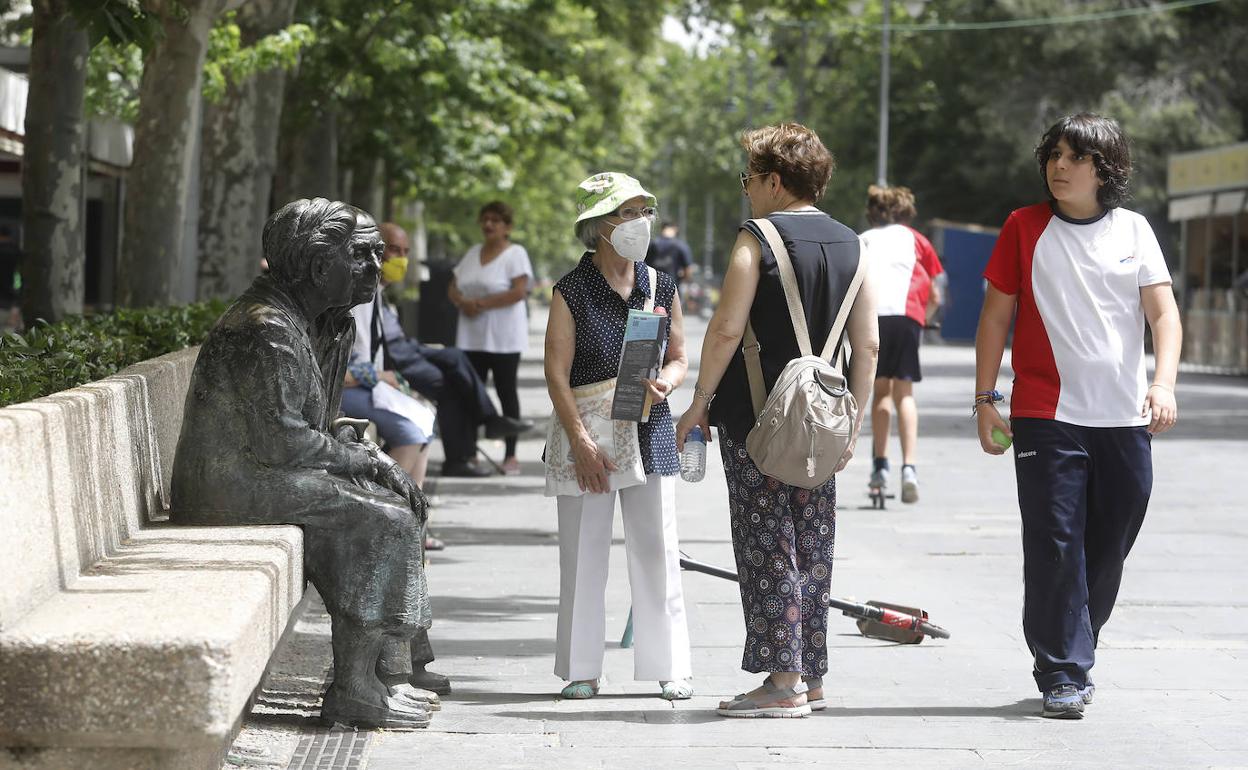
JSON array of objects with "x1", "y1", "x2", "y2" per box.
[{"x1": 983, "y1": 203, "x2": 1171, "y2": 428}]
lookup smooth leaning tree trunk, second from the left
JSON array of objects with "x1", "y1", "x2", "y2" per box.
[{"x1": 117, "y1": 0, "x2": 231, "y2": 306}]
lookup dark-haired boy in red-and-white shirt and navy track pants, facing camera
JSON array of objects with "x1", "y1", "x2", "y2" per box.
[{"x1": 975, "y1": 114, "x2": 1182, "y2": 719}]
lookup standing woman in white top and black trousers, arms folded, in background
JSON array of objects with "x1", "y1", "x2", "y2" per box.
[{"x1": 448, "y1": 201, "x2": 533, "y2": 475}]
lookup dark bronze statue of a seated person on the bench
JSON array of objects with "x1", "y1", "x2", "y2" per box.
[{"x1": 170, "y1": 198, "x2": 437, "y2": 729}]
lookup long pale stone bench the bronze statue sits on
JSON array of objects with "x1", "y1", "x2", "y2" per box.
[{"x1": 0, "y1": 348, "x2": 303, "y2": 770}]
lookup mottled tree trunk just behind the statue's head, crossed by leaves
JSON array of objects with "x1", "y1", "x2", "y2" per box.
[{"x1": 197, "y1": 0, "x2": 296, "y2": 300}]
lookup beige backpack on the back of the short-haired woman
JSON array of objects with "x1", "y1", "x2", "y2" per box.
[{"x1": 741, "y1": 218, "x2": 866, "y2": 489}]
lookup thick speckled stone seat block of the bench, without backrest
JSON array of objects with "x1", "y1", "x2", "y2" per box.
[{"x1": 0, "y1": 527, "x2": 303, "y2": 750}]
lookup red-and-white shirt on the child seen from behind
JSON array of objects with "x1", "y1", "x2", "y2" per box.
[{"x1": 861, "y1": 225, "x2": 945, "y2": 326}]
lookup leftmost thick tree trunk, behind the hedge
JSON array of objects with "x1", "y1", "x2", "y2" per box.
[{"x1": 21, "y1": 0, "x2": 90, "y2": 327}]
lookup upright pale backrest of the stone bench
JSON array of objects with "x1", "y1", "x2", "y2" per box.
[{"x1": 0, "y1": 347, "x2": 198, "y2": 631}]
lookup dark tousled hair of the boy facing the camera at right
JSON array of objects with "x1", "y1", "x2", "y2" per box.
[{"x1": 1036, "y1": 112, "x2": 1131, "y2": 208}]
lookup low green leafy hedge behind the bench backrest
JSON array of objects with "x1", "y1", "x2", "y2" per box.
[{"x1": 0, "y1": 301, "x2": 226, "y2": 407}]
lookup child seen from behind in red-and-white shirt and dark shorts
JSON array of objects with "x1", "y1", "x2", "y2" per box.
[{"x1": 861, "y1": 185, "x2": 945, "y2": 503}]
